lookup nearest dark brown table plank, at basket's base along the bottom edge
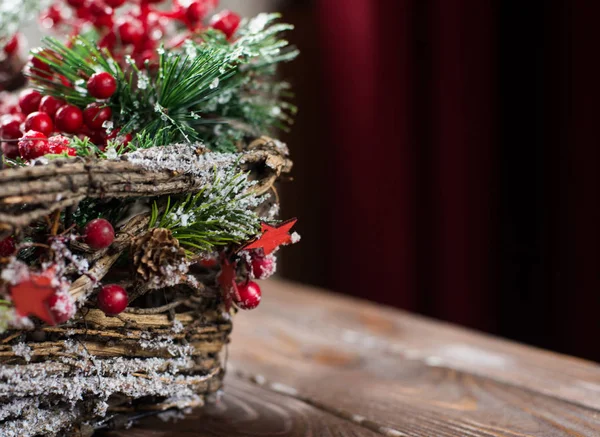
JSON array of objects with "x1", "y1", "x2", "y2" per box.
[{"x1": 98, "y1": 376, "x2": 377, "y2": 437}]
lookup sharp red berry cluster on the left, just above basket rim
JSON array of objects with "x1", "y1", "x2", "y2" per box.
[{"x1": 0, "y1": 70, "x2": 120, "y2": 160}]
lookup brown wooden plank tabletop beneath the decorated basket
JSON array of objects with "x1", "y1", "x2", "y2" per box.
[{"x1": 107, "y1": 281, "x2": 600, "y2": 437}]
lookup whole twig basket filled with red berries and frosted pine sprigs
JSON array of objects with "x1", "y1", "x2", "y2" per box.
[{"x1": 0, "y1": 0, "x2": 299, "y2": 437}]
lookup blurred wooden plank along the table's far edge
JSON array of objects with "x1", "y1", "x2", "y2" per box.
[{"x1": 240, "y1": 281, "x2": 600, "y2": 410}]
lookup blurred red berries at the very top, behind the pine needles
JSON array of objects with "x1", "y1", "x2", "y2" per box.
[{"x1": 34, "y1": 0, "x2": 240, "y2": 66}]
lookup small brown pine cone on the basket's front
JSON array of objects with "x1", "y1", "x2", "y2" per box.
[{"x1": 131, "y1": 228, "x2": 189, "y2": 289}]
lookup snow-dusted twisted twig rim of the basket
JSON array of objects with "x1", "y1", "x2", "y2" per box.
[{"x1": 0, "y1": 140, "x2": 292, "y2": 232}]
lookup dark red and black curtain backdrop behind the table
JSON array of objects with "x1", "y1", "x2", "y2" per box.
[{"x1": 280, "y1": 0, "x2": 600, "y2": 360}]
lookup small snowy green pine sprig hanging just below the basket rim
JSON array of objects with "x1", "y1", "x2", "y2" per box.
[{"x1": 150, "y1": 170, "x2": 263, "y2": 252}]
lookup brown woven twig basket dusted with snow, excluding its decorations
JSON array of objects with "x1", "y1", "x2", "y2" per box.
[{"x1": 0, "y1": 138, "x2": 291, "y2": 437}]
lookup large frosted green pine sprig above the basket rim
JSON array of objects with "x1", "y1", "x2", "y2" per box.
[{"x1": 31, "y1": 14, "x2": 298, "y2": 152}]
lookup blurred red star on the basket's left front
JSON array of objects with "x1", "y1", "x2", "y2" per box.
[{"x1": 10, "y1": 274, "x2": 56, "y2": 325}]
